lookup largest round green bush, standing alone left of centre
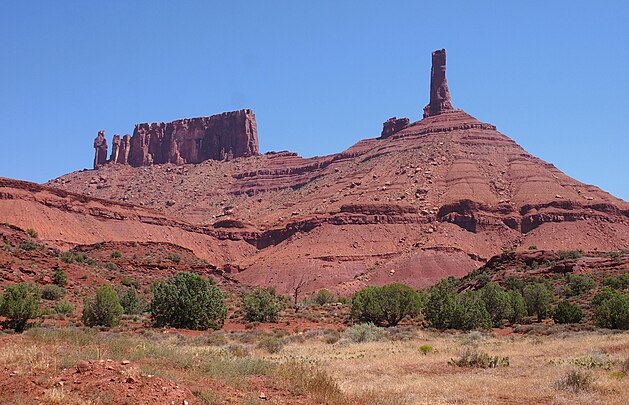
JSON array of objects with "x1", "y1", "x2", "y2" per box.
[{"x1": 150, "y1": 272, "x2": 227, "y2": 330}]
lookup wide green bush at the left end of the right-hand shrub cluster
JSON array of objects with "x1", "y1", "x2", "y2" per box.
[{"x1": 351, "y1": 284, "x2": 421, "y2": 326}]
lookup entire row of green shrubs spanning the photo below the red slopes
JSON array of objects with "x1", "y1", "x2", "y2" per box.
[{"x1": 0, "y1": 269, "x2": 629, "y2": 331}]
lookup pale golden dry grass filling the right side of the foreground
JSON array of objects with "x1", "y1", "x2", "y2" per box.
[{"x1": 283, "y1": 332, "x2": 629, "y2": 404}]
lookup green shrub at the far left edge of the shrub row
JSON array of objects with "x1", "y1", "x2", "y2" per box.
[{"x1": 0, "y1": 283, "x2": 40, "y2": 333}]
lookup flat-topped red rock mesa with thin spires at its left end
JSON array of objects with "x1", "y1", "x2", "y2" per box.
[{"x1": 94, "y1": 109, "x2": 259, "y2": 168}]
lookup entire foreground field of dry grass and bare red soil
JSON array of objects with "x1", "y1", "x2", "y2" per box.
[{"x1": 0, "y1": 327, "x2": 629, "y2": 404}]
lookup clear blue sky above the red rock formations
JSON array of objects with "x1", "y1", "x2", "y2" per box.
[{"x1": 0, "y1": 0, "x2": 629, "y2": 200}]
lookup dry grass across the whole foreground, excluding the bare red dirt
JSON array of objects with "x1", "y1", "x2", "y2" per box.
[{"x1": 0, "y1": 329, "x2": 629, "y2": 405}]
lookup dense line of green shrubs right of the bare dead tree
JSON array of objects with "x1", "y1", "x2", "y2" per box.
[{"x1": 352, "y1": 276, "x2": 629, "y2": 330}]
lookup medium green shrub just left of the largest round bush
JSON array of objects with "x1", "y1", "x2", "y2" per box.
[{"x1": 83, "y1": 284, "x2": 124, "y2": 326}]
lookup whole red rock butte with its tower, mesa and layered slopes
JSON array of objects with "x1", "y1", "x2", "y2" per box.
[{"x1": 0, "y1": 50, "x2": 629, "y2": 293}]
